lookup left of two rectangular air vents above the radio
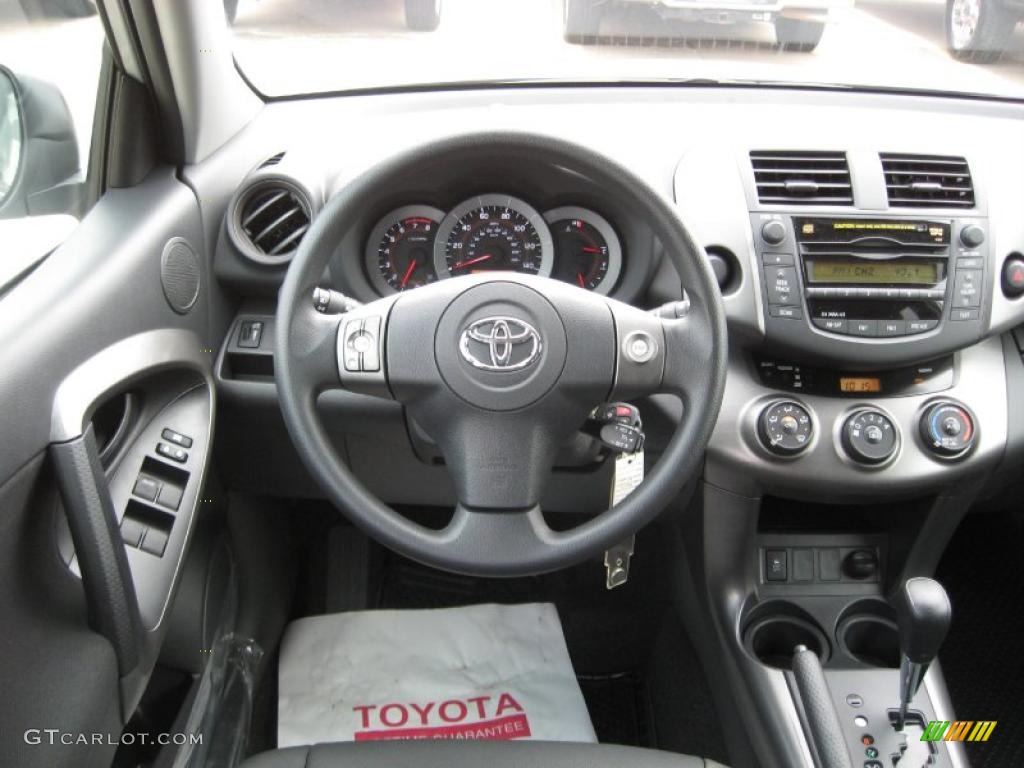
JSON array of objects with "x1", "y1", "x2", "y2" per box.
[{"x1": 751, "y1": 151, "x2": 853, "y2": 206}]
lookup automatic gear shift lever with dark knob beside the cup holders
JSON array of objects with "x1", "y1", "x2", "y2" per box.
[{"x1": 893, "y1": 577, "x2": 952, "y2": 730}]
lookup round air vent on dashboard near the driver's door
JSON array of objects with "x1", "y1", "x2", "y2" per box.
[{"x1": 230, "y1": 178, "x2": 311, "y2": 264}]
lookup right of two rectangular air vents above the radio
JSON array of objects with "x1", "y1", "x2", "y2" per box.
[{"x1": 881, "y1": 153, "x2": 974, "y2": 208}]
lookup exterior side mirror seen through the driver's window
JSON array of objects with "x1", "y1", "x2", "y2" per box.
[{"x1": 0, "y1": 67, "x2": 83, "y2": 219}]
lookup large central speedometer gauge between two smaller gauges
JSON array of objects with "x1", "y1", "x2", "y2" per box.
[{"x1": 434, "y1": 195, "x2": 554, "y2": 278}]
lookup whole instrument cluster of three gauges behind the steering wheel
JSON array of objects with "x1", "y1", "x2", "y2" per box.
[{"x1": 366, "y1": 195, "x2": 623, "y2": 295}]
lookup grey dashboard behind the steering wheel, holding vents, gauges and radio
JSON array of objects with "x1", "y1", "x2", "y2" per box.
[{"x1": 197, "y1": 87, "x2": 1024, "y2": 510}]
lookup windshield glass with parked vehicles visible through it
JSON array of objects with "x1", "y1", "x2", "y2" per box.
[{"x1": 232, "y1": 0, "x2": 1024, "y2": 98}]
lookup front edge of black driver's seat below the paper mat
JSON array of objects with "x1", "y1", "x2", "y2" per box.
[{"x1": 242, "y1": 740, "x2": 723, "y2": 768}]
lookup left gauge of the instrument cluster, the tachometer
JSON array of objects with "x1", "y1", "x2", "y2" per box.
[{"x1": 367, "y1": 206, "x2": 444, "y2": 294}]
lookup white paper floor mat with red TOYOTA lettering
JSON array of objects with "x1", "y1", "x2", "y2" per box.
[{"x1": 278, "y1": 603, "x2": 597, "y2": 746}]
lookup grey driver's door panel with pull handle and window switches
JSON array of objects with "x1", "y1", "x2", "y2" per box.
[{"x1": 0, "y1": 168, "x2": 223, "y2": 766}]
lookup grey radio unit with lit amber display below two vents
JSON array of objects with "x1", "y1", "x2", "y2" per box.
[{"x1": 752, "y1": 214, "x2": 991, "y2": 362}]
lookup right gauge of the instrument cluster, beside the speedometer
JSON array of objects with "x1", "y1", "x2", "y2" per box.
[{"x1": 544, "y1": 207, "x2": 623, "y2": 295}]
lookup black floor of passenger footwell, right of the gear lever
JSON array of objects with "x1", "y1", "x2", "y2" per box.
[{"x1": 937, "y1": 514, "x2": 1024, "y2": 768}]
